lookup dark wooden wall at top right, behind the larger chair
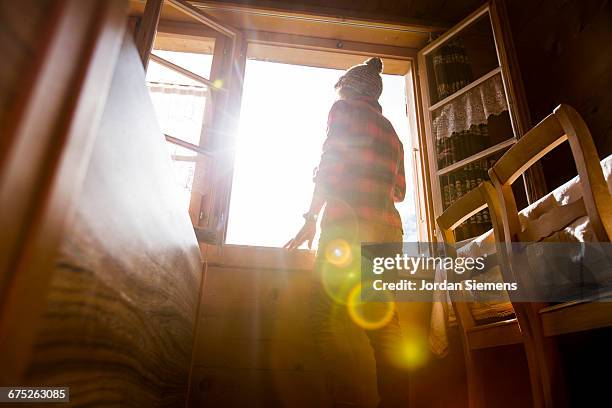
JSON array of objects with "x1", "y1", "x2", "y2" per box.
[{"x1": 506, "y1": 0, "x2": 612, "y2": 189}]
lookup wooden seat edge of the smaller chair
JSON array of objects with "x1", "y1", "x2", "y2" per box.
[{"x1": 466, "y1": 318, "x2": 523, "y2": 350}]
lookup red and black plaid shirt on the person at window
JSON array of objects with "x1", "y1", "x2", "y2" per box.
[{"x1": 314, "y1": 99, "x2": 406, "y2": 228}]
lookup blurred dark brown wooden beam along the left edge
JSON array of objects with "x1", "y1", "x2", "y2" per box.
[{"x1": 0, "y1": 0, "x2": 126, "y2": 384}]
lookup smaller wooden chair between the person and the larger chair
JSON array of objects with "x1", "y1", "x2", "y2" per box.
[{"x1": 436, "y1": 181, "x2": 541, "y2": 408}]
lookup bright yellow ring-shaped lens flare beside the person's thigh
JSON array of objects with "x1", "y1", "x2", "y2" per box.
[{"x1": 347, "y1": 284, "x2": 395, "y2": 330}]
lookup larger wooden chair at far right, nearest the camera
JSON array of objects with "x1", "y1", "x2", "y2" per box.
[{"x1": 489, "y1": 105, "x2": 612, "y2": 407}]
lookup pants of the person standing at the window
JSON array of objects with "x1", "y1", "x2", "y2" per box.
[{"x1": 311, "y1": 222, "x2": 408, "y2": 408}]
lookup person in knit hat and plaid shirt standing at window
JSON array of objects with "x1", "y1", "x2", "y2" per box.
[{"x1": 285, "y1": 58, "x2": 408, "y2": 407}]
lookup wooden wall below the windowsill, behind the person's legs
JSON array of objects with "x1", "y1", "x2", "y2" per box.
[{"x1": 191, "y1": 245, "x2": 440, "y2": 408}]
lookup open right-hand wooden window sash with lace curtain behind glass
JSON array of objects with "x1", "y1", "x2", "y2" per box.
[{"x1": 418, "y1": 1, "x2": 544, "y2": 240}]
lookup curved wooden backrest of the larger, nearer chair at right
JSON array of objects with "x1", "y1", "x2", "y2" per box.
[{"x1": 489, "y1": 105, "x2": 612, "y2": 242}]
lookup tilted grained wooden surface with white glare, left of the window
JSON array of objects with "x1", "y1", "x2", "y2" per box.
[{"x1": 22, "y1": 35, "x2": 202, "y2": 407}]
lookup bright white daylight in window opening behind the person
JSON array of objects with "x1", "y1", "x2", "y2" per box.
[{"x1": 227, "y1": 60, "x2": 417, "y2": 247}]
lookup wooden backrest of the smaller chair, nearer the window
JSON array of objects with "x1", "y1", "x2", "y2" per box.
[{"x1": 436, "y1": 181, "x2": 506, "y2": 330}]
